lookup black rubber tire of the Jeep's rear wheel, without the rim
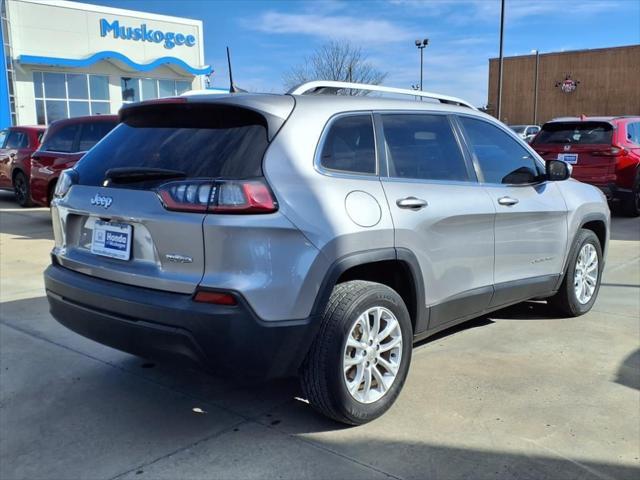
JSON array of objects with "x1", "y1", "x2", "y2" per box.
[{"x1": 301, "y1": 280, "x2": 413, "y2": 425}]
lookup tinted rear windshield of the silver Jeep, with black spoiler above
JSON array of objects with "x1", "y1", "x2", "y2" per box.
[{"x1": 75, "y1": 104, "x2": 268, "y2": 188}]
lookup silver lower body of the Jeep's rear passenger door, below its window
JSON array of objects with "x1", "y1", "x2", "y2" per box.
[{"x1": 382, "y1": 178, "x2": 495, "y2": 305}]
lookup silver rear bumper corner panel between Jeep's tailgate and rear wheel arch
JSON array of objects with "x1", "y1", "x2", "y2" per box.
[{"x1": 200, "y1": 212, "x2": 329, "y2": 321}]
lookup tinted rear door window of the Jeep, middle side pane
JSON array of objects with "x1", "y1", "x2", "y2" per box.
[{"x1": 381, "y1": 114, "x2": 470, "y2": 182}]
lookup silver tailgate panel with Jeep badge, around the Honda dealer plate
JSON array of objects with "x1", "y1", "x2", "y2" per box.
[{"x1": 51, "y1": 185, "x2": 205, "y2": 293}]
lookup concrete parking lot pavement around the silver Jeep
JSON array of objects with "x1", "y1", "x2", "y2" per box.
[{"x1": 0, "y1": 192, "x2": 640, "y2": 480}]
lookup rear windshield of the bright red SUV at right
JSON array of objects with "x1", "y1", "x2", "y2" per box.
[{"x1": 534, "y1": 122, "x2": 613, "y2": 145}]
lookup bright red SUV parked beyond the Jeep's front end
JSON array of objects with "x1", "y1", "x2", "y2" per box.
[{"x1": 531, "y1": 115, "x2": 640, "y2": 217}]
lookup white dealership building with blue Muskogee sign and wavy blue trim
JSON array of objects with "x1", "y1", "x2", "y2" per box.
[{"x1": 0, "y1": 0, "x2": 211, "y2": 128}]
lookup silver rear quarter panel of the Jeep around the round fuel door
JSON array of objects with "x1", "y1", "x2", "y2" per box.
[{"x1": 263, "y1": 99, "x2": 394, "y2": 314}]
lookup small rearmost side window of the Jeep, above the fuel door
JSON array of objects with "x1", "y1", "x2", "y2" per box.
[{"x1": 320, "y1": 114, "x2": 376, "y2": 175}]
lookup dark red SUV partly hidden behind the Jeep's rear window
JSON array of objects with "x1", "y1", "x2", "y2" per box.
[{"x1": 30, "y1": 115, "x2": 118, "y2": 206}]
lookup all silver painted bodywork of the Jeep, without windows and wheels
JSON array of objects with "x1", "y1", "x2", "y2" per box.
[{"x1": 52, "y1": 94, "x2": 609, "y2": 321}]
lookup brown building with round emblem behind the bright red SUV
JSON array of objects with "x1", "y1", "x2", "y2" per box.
[{"x1": 487, "y1": 45, "x2": 640, "y2": 125}]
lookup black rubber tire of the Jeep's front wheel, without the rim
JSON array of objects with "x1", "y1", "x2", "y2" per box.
[{"x1": 548, "y1": 229, "x2": 603, "y2": 317}]
